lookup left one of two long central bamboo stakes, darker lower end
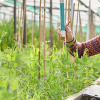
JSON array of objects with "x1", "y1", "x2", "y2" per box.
[{"x1": 38, "y1": 0, "x2": 41, "y2": 79}]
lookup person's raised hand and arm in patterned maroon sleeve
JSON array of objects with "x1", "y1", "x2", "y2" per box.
[{"x1": 57, "y1": 23, "x2": 100, "y2": 58}]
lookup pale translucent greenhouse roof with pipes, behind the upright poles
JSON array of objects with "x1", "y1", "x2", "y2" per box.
[{"x1": 0, "y1": 0, "x2": 100, "y2": 26}]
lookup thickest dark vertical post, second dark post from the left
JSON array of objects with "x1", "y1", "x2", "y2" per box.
[{"x1": 23, "y1": 0, "x2": 27, "y2": 45}]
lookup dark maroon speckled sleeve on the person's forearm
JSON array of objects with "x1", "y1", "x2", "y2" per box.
[{"x1": 69, "y1": 35, "x2": 100, "y2": 58}]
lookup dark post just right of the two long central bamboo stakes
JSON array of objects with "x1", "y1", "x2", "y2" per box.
[{"x1": 50, "y1": 0, "x2": 53, "y2": 48}]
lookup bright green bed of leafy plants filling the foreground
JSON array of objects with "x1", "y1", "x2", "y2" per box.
[{"x1": 0, "y1": 44, "x2": 100, "y2": 100}]
